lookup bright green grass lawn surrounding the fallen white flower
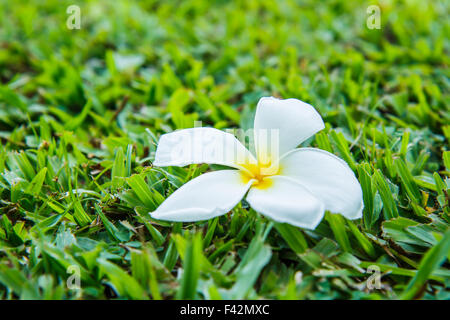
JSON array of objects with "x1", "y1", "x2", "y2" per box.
[{"x1": 0, "y1": 0, "x2": 450, "y2": 299}]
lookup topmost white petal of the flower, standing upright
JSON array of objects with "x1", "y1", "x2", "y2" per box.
[{"x1": 254, "y1": 97, "x2": 325, "y2": 161}]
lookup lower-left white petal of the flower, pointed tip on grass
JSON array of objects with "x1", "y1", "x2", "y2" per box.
[{"x1": 150, "y1": 170, "x2": 253, "y2": 222}]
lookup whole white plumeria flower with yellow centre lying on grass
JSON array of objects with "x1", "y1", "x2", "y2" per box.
[{"x1": 150, "y1": 97, "x2": 363, "y2": 229}]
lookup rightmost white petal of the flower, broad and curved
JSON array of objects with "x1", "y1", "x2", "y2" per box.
[{"x1": 280, "y1": 148, "x2": 364, "y2": 219}]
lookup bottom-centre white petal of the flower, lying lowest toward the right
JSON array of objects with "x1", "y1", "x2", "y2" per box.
[{"x1": 246, "y1": 176, "x2": 325, "y2": 229}]
